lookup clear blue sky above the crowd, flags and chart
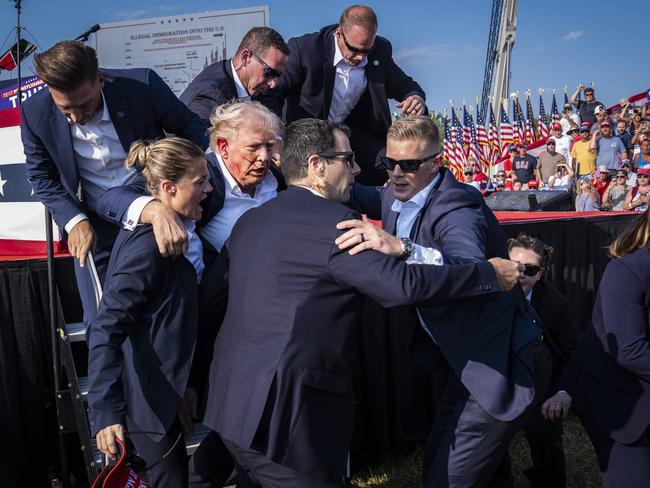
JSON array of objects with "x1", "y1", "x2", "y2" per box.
[{"x1": 0, "y1": 0, "x2": 650, "y2": 111}]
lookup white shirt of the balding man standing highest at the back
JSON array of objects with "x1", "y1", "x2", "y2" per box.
[{"x1": 327, "y1": 32, "x2": 368, "y2": 123}]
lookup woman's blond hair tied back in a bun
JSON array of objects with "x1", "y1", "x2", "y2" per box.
[{"x1": 124, "y1": 137, "x2": 205, "y2": 195}]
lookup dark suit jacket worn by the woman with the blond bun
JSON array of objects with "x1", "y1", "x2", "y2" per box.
[{"x1": 87, "y1": 226, "x2": 198, "y2": 440}]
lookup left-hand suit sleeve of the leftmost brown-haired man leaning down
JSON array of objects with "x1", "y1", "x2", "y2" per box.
[{"x1": 20, "y1": 105, "x2": 83, "y2": 229}]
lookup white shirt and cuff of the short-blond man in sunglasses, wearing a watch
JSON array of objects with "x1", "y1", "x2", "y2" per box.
[{"x1": 391, "y1": 174, "x2": 444, "y2": 266}]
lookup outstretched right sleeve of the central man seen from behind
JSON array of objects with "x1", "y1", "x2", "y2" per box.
[{"x1": 328, "y1": 213, "x2": 500, "y2": 307}]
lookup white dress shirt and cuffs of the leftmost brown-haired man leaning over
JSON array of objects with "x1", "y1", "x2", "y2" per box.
[{"x1": 65, "y1": 93, "x2": 151, "y2": 232}]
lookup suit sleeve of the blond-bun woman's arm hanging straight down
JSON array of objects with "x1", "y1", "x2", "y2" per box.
[{"x1": 87, "y1": 236, "x2": 166, "y2": 435}]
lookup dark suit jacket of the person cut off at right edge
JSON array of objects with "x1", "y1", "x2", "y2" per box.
[{"x1": 563, "y1": 247, "x2": 650, "y2": 444}]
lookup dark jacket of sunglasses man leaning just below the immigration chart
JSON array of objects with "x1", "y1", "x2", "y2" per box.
[{"x1": 179, "y1": 58, "x2": 275, "y2": 122}]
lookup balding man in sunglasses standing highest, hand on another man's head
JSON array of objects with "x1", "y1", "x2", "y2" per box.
[{"x1": 269, "y1": 5, "x2": 426, "y2": 185}]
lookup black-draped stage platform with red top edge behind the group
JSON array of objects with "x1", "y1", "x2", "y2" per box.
[{"x1": 0, "y1": 212, "x2": 635, "y2": 488}]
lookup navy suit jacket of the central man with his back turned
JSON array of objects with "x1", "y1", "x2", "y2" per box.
[{"x1": 204, "y1": 186, "x2": 498, "y2": 481}]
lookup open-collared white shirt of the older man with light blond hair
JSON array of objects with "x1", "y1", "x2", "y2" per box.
[{"x1": 201, "y1": 152, "x2": 278, "y2": 251}]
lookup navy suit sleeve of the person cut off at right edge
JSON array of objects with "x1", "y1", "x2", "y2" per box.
[{"x1": 598, "y1": 259, "x2": 650, "y2": 382}]
